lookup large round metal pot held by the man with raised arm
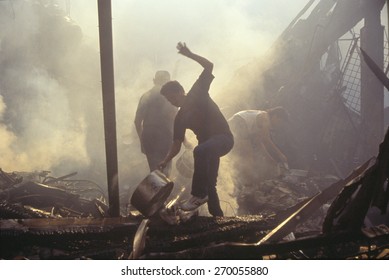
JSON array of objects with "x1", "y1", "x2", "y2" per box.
[{"x1": 130, "y1": 170, "x2": 174, "y2": 217}]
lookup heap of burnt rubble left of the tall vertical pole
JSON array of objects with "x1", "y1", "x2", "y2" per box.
[{"x1": 0, "y1": 169, "x2": 108, "y2": 219}]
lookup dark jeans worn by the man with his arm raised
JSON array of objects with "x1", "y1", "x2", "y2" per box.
[{"x1": 191, "y1": 134, "x2": 234, "y2": 216}]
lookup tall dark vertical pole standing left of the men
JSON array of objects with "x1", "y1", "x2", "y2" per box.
[{"x1": 97, "y1": 0, "x2": 120, "y2": 217}]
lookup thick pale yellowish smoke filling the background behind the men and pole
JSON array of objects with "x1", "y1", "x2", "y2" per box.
[{"x1": 0, "y1": 0, "x2": 307, "y2": 217}]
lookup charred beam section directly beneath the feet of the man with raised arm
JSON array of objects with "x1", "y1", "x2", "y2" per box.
[{"x1": 145, "y1": 215, "x2": 278, "y2": 252}]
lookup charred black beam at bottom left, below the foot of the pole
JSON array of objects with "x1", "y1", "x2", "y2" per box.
[{"x1": 0, "y1": 218, "x2": 139, "y2": 259}]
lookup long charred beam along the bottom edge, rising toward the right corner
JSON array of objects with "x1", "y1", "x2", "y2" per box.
[{"x1": 141, "y1": 229, "x2": 389, "y2": 260}]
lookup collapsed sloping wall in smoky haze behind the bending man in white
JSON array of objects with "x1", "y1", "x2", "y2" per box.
[{"x1": 220, "y1": 0, "x2": 385, "y2": 177}]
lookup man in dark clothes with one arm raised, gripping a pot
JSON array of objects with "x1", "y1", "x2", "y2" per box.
[{"x1": 159, "y1": 42, "x2": 234, "y2": 216}]
